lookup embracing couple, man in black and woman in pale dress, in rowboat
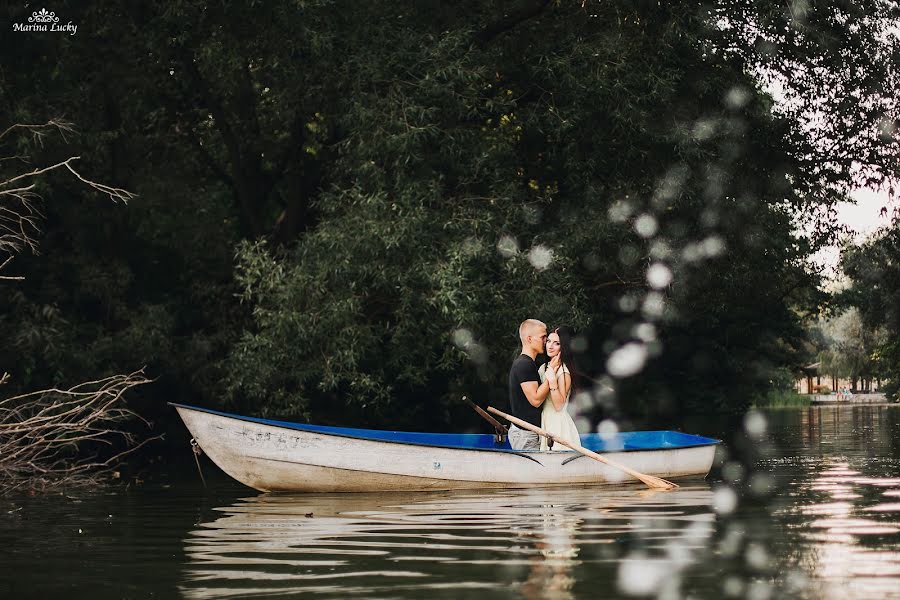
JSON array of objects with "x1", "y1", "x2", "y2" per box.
[{"x1": 509, "y1": 319, "x2": 581, "y2": 451}]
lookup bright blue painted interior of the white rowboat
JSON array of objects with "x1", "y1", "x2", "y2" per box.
[{"x1": 170, "y1": 402, "x2": 720, "y2": 452}]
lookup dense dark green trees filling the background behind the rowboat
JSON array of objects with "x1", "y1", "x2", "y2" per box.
[{"x1": 0, "y1": 0, "x2": 900, "y2": 428}]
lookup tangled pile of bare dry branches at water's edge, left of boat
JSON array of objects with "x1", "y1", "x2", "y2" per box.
[{"x1": 0, "y1": 371, "x2": 157, "y2": 494}]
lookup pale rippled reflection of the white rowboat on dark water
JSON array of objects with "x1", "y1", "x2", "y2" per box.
[{"x1": 181, "y1": 484, "x2": 715, "y2": 599}]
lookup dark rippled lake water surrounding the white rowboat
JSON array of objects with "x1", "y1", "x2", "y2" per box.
[{"x1": 0, "y1": 405, "x2": 900, "y2": 600}]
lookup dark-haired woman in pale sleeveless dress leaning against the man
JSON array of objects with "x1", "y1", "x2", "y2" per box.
[{"x1": 538, "y1": 327, "x2": 581, "y2": 452}]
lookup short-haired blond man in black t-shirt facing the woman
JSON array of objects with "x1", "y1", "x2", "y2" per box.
[{"x1": 509, "y1": 319, "x2": 550, "y2": 450}]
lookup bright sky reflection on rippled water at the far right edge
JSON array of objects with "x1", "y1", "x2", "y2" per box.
[{"x1": 764, "y1": 406, "x2": 900, "y2": 600}]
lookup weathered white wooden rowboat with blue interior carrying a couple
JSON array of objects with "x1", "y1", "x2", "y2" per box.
[{"x1": 172, "y1": 403, "x2": 720, "y2": 492}]
